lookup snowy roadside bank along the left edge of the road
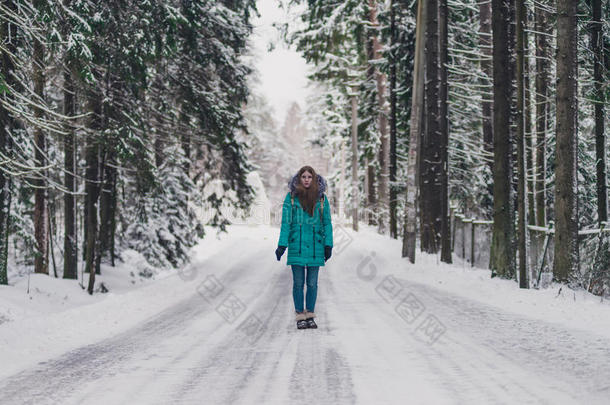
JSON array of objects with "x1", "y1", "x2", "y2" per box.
[{"x1": 0, "y1": 229, "x2": 236, "y2": 379}]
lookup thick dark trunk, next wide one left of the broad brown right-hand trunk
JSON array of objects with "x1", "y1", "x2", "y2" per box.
[{"x1": 490, "y1": 0, "x2": 514, "y2": 278}]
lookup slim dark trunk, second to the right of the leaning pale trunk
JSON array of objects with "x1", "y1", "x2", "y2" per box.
[{"x1": 439, "y1": 0, "x2": 452, "y2": 263}]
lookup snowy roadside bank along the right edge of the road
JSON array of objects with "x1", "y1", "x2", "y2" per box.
[{"x1": 343, "y1": 224, "x2": 610, "y2": 337}]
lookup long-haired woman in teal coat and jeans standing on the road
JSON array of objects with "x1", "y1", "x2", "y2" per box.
[{"x1": 275, "y1": 166, "x2": 333, "y2": 329}]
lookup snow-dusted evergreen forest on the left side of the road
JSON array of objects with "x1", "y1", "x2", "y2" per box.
[{"x1": 0, "y1": 0, "x2": 255, "y2": 293}]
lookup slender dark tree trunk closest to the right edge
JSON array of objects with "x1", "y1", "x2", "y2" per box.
[{"x1": 591, "y1": 0, "x2": 608, "y2": 225}]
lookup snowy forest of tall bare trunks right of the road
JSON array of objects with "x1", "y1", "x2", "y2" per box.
[{"x1": 283, "y1": 0, "x2": 610, "y2": 295}]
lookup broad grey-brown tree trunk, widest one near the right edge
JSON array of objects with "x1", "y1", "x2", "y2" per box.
[{"x1": 553, "y1": 0, "x2": 578, "y2": 283}]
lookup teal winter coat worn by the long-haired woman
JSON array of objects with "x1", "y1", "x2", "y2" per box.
[{"x1": 278, "y1": 175, "x2": 333, "y2": 266}]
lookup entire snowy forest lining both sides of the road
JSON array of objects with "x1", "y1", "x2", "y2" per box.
[{"x1": 0, "y1": 0, "x2": 610, "y2": 295}]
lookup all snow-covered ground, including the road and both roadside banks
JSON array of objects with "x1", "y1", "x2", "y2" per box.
[{"x1": 0, "y1": 224, "x2": 610, "y2": 404}]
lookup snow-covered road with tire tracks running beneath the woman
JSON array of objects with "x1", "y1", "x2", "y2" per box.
[{"x1": 0, "y1": 226, "x2": 610, "y2": 404}]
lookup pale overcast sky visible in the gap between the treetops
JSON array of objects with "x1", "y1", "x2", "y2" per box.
[{"x1": 252, "y1": 0, "x2": 307, "y2": 126}]
